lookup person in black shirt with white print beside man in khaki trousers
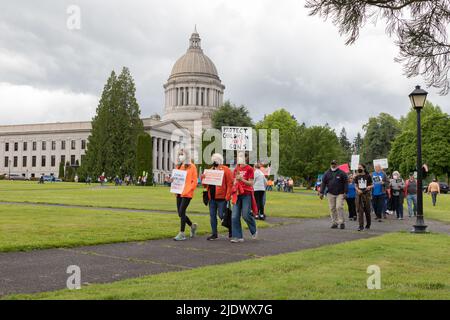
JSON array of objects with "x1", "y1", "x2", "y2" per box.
[{"x1": 354, "y1": 164, "x2": 373, "y2": 231}]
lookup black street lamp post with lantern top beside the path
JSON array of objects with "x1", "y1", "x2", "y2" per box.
[{"x1": 409, "y1": 86, "x2": 428, "y2": 233}]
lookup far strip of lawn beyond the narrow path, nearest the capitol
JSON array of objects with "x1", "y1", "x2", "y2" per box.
[{"x1": 0, "y1": 181, "x2": 328, "y2": 218}]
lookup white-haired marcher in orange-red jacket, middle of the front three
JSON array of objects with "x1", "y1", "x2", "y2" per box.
[{"x1": 202, "y1": 153, "x2": 233, "y2": 241}]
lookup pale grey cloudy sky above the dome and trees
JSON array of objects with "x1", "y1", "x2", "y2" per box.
[{"x1": 0, "y1": 0, "x2": 450, "y2": 137}]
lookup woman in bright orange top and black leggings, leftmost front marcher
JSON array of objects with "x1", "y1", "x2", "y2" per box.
[{"x1": 174, "y1": 149, "x2": 198, "y2": 241}]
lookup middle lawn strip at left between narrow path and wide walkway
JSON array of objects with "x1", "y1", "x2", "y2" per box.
[{"x1": 0, "y1": 204, "x2": 268, "y2": 252}]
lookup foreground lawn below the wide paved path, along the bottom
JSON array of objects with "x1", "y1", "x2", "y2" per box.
[{"x1": 5, "y1": 233, "x2": 450, "y2": 300}]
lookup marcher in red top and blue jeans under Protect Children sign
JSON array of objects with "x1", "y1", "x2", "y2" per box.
[{"x1": 231, "y1": 151, "x2": 258, "y2": 243}]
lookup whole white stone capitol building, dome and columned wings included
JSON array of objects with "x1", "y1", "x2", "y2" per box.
[{"x1": 0, "y1": 30, "x2": 225, "y2": 183}]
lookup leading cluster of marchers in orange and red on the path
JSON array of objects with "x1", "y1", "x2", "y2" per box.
[{"x1": 174, "y1": 149, "x2": 267, "y2": 243}]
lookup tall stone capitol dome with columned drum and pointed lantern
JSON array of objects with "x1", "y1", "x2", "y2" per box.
[{"x1": 163, "y1": 30, "x2": 225, "y2": 132}]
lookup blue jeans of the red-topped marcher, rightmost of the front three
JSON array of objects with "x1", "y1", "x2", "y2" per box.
[{"x1": 231, "y1": 195, "x2": 256, "y2": 239}]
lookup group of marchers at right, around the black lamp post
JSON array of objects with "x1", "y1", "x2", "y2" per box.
[{"x1": 319, "y1": 160, "x2": 439, "y2": 231}]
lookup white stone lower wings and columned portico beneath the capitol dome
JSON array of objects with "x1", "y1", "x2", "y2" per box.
[{"x1": 0, "y1": 118, "x2": 190, "y2": 183}]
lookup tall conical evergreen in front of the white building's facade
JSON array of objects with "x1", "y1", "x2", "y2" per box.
[{"x1": 80, "y1": 67, "x2": 144, "y2": 177}]
